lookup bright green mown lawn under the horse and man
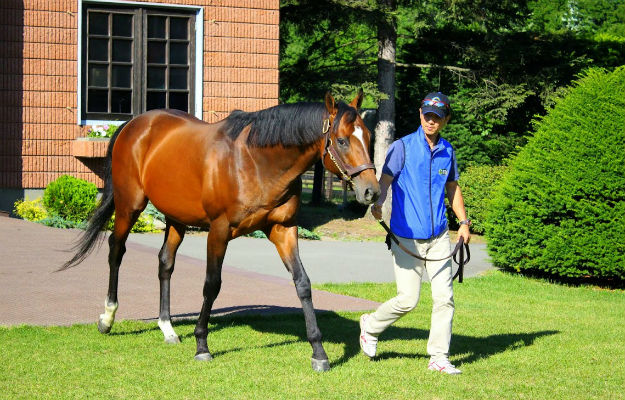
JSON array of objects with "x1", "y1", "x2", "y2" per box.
[{"x1": 0, "y1": 272, "x2": 625, "y2": 400}]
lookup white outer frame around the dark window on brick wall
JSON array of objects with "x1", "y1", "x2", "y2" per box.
[{"x1": 76, "y1": 0, "x2": 204, "y2": 125}]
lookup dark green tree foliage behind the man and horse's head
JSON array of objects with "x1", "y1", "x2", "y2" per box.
[{"x1": 280, "y1": 0, "x2": 625, "y2": 169}]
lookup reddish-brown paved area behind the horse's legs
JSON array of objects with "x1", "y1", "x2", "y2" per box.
[{"x1": 0, "y1": 216, "x2": 379, "y2": 326}]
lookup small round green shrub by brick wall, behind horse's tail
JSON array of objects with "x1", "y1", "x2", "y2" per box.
[{"x1": 43, "y1": 175, "x2": 98, "y2": 222}]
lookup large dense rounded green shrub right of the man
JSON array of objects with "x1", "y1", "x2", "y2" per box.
[{"x1": 486, "y1": 66, "x2": 625, "y2": 283}]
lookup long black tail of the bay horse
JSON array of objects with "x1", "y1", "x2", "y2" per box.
[{"x1": 58, "y1": 121, "x2": 129, "y2": 271}]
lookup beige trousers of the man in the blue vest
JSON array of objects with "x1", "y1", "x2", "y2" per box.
[{"x1": 365, "y1": 231, "x2": 454, "y2": 360}]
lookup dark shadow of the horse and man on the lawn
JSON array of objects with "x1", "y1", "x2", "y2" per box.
[{"x1": 125, "y1": 305, "x2": 559, "y2": 366}]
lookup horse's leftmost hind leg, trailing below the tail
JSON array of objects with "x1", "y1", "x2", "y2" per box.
[{"x1": 98, "y1": 199, "x2": 147, "y2": 333}]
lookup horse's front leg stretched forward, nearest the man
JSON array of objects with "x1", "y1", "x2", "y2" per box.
[{"x1": 269, "y1": 225, "x2": 330, "y2": 371}]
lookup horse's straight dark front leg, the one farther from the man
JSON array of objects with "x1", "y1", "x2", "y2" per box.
[{"x1": 194, "y1": 218, "x2": 230, "y2": 361}]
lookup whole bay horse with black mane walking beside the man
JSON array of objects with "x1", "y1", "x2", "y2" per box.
[{"x1": 60, "y1": 91, "x2": 380, "y2": 371}]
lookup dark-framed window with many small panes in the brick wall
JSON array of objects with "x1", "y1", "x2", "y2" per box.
[{"x1": 80, "y1": 6, "x2": 195, "y2": 120}]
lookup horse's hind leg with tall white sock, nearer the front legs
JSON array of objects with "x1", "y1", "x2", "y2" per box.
[{"x1": 158, "y1": 219, "x2": 187, "y2": 343}]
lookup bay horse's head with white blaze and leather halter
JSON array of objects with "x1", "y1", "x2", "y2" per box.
[{"x1": 322, "y1": 91, "x2": 380, "y2": 204}]
